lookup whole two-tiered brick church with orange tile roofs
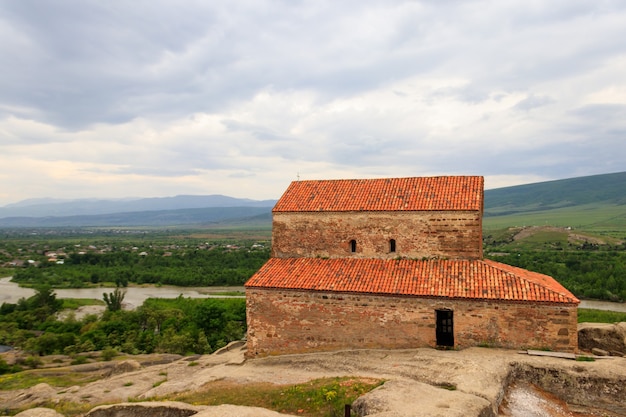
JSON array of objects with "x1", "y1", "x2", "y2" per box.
[{"x1": 245, "y1": 176, "x2": 579, "y2": 357}]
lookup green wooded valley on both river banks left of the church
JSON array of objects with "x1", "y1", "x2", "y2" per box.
[{"x1": 0, "y1": 230, "x2": 260, "y2": 373}]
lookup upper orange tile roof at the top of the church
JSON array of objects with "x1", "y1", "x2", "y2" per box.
[{"x1": 273, "y1": 176, "x2": 484, "y2": 212}]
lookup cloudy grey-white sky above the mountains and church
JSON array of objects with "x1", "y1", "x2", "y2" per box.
[{"x1": 0, "y1": 0, "x2": 626, "y2": 206}]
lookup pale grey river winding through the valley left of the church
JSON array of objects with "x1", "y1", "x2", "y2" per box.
[{"x1": 0, "y1": 277, "x2": 244, "y2": 309}]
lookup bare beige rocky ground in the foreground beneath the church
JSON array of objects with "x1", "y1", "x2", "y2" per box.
[{"x1": 0, "y1": 324, "x2": 626, "y2": 417}]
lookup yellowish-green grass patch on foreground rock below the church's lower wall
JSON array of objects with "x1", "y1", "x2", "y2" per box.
[{"x1": 167, "y1": 377, "x2": 384, "y2": 417}]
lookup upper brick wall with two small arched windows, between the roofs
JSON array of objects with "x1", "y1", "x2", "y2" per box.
[{"x1": 272, "y1": 211, "x2": 482, "y2": 259}]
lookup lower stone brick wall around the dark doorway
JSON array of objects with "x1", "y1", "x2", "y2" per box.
[{"x1": 246, "y1": 288, "x2": 578, "y2": 357}]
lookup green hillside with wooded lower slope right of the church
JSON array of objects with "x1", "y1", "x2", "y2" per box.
[{"x1": 483, "y1": 172, "x2": 626, "y2": 301}]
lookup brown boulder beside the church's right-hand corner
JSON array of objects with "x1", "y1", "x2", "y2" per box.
[{"x1": 578, "y1": 323, "x2": 626, "y2": 356}]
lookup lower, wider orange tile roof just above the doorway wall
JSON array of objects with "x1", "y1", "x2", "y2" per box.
[{"x1": 245, "y1": 258, "x2": 579, "y2": 304}]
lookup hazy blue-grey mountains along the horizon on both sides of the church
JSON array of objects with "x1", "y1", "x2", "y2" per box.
[{"x1": 0, "y1": 172, "x2": 626, "y2": 227}]
